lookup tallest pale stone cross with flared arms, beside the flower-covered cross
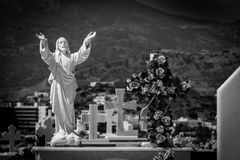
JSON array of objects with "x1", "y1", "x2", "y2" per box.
[{"x1": 105, "y1": 88, "x2": 137, "y2": 136}]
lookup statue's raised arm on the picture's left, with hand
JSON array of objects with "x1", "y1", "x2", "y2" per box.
[{"x1": 36, "y1": 33, "x2": 53, "y2": 65}]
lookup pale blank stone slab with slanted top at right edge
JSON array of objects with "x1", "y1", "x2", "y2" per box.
[{"x1": 217, "y1": 67, "x2": 240, "y2": 160}]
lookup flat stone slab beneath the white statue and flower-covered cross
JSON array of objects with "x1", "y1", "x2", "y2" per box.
[{"x1": 33, "y1": 147, "x2": 191, "y2": 160}]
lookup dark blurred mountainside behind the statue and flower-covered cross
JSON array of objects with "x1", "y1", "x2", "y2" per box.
[{"x1": 0, "y1": 0, "x2": 240, "y2": 104}]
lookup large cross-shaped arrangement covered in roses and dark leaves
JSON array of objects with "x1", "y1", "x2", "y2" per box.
[{"x1": 126, "y1": 51, "x2": 190, "y2": 159}]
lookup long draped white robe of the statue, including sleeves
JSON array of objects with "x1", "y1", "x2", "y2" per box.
[{"x1": 40, "y1": 43, "x2": 90, "y2": 145}]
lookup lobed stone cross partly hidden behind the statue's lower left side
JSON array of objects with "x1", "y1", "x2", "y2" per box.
[{"x1": 36, "y1": 115, "x2": 55, "y2": 145}]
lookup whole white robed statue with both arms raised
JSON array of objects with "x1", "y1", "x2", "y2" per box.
[{"x1": 36, "y1": 32, "x2": 96, "y2": 146}]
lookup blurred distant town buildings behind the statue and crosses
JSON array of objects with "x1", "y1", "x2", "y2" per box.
[{"x1": 0, "y1": 82, "x2": 216, "y2": 141}]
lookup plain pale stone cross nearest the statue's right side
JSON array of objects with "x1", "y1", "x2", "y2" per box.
[{"x1": 81, "y1": 104, "x2": 111, "y2": 139}]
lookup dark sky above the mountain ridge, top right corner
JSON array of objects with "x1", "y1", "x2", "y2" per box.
[{"x1": 135, "y1": 0, "x2": 240, "y2": 23}]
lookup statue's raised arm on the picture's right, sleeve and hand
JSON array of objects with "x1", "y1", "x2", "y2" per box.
[{"x1": 71, "y1": 32, "x2": 96, "y2": 66}]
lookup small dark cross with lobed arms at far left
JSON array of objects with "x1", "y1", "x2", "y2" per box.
[{"x1": 2, "y1": 124, "x2": 21, "y2": 152}]
